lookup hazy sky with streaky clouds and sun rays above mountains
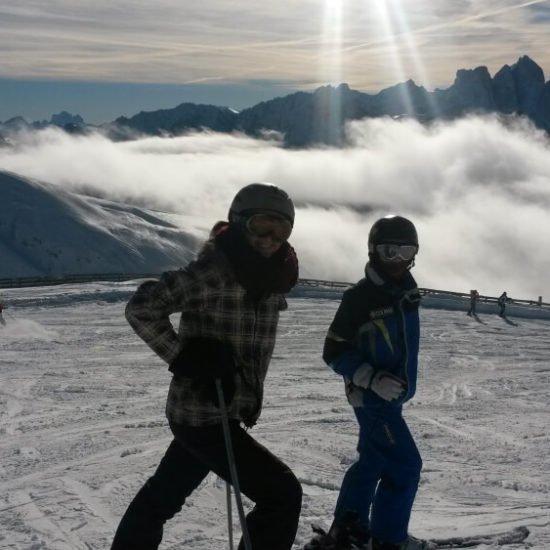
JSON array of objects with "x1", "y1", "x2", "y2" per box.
[{"x1": 0, "y1": 0, "x2": 550, "y2": 123}]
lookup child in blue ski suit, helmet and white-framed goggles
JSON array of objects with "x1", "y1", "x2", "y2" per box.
[{"x1": 305, "y1": 216, "x2": 431, "y2": 550}]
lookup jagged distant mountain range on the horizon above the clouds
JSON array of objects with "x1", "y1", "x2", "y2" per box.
[{"x1": 0, "y1": 56, "x2": 550, "y2": 148}]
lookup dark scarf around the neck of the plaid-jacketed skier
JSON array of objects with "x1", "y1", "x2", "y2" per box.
[{"x1": 214, "y1": 224, "x2": 298, "y2": 302}]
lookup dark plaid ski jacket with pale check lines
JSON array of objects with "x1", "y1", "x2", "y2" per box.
[{"x1": 126, "y1": 249, "x2": 287, "y2": 426}]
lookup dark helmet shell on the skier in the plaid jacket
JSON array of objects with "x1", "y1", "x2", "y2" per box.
[{"x1": 227, "y1": 183, "x2": 294, "y2": 225}]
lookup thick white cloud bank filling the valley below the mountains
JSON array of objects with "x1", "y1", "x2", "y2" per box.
[{"x1": 0, "y1": 113, "x2": 550, "y2": 301}]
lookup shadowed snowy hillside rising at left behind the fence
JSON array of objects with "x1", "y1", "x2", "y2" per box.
[{"x1": 0, "y1": 171, "x2": 198, "y2": 278}]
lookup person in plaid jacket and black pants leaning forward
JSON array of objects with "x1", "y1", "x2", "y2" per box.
[{"x1": 112, "y1": 183, "x2": 302, "y2": 550}]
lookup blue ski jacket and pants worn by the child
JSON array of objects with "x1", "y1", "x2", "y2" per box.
[{"x1": 323, "y1": 264, "x2": 422, "y2": 544}]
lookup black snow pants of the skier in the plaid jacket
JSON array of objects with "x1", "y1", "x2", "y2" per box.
[{"x1": 111, "y1": 422, "x2": 302, "y2": 550}]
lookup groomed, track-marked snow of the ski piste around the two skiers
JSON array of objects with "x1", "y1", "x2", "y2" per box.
[{"x1": 0, "y1": 285, "x2": 550, "y2": 550}]
